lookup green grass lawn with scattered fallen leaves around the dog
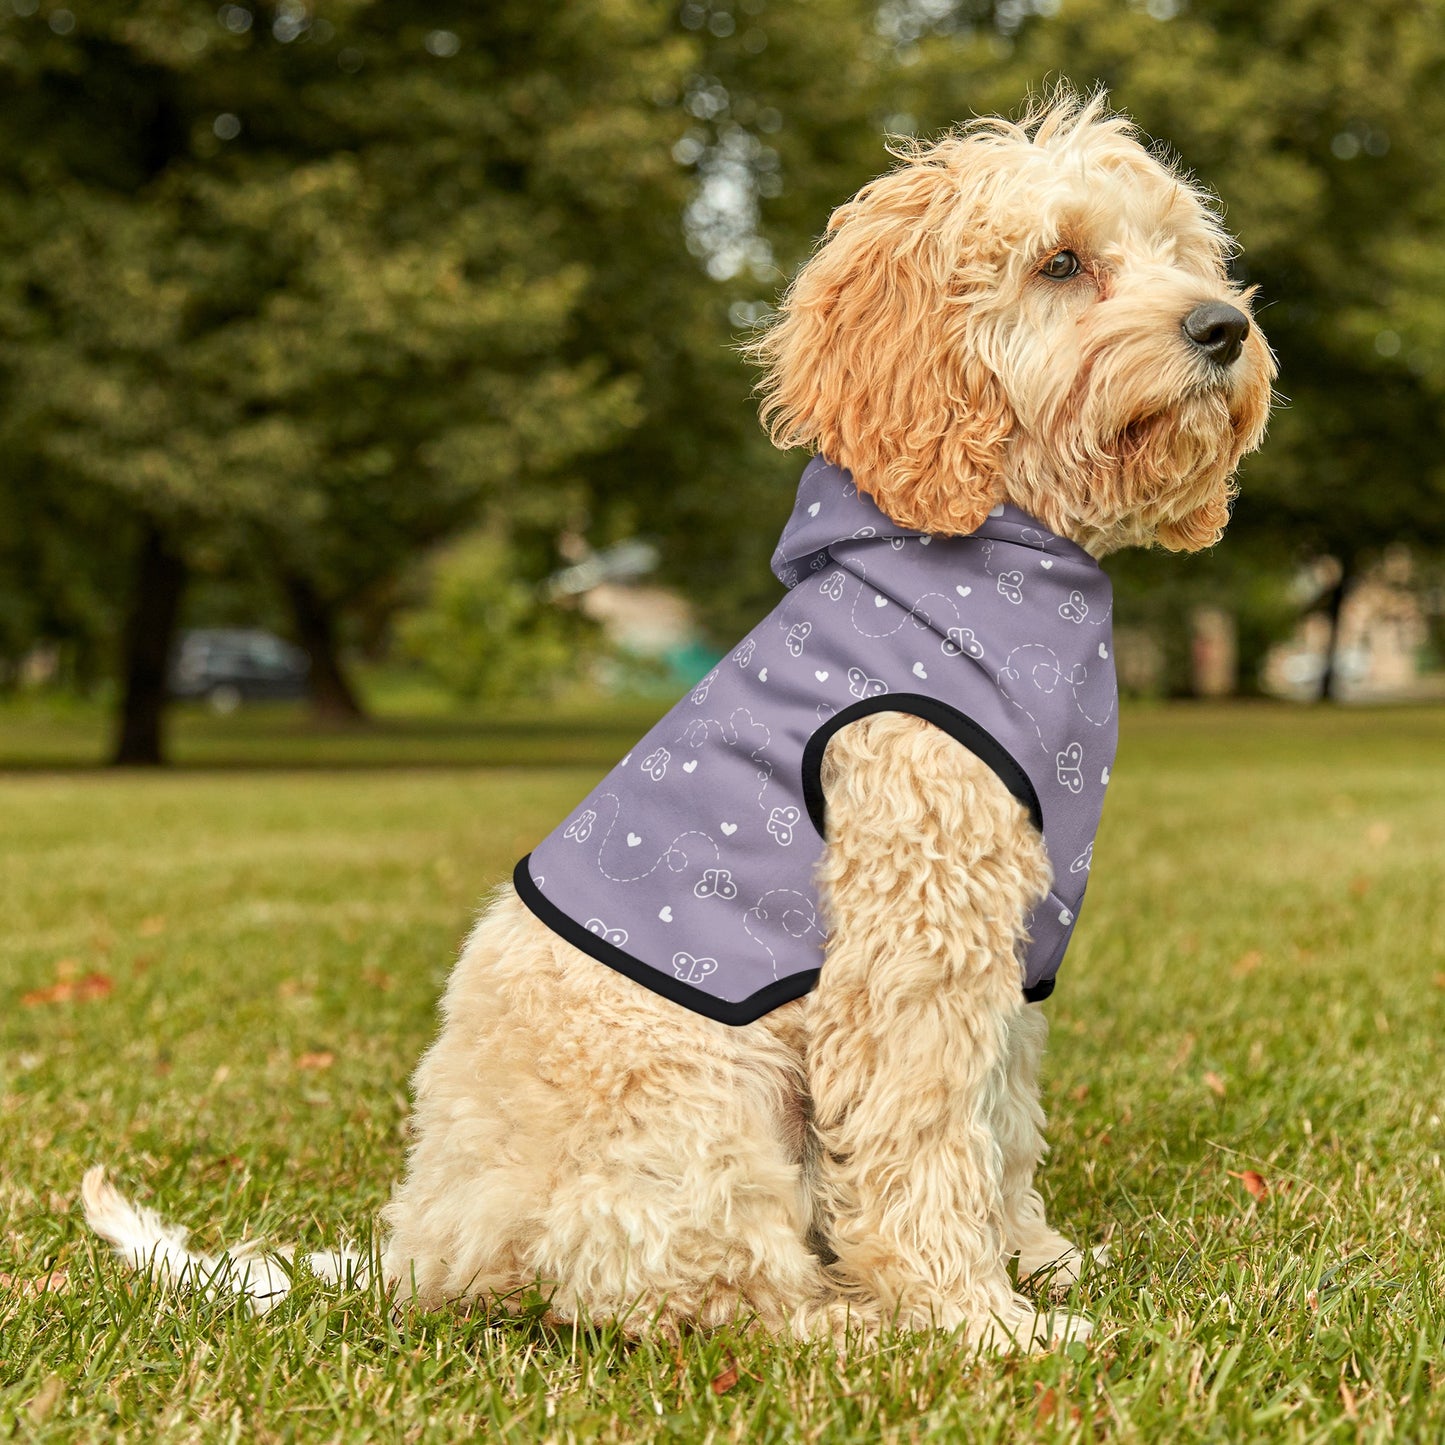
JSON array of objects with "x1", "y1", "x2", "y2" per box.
[{"x1": 0, "y1": 707, "x2": 1445, "y2": 1442}]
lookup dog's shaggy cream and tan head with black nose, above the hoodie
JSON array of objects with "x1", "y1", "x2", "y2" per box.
[{"x1": 751, "y1": 94, "x2": 1274, "y2": 553}]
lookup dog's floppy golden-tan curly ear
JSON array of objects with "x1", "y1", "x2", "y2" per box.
[{"x1": 749, "y1": 139, "x2": 1013, "y2": 535}]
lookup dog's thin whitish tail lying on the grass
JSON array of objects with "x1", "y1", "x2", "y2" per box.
[{"x1": 81, "y1": 1165, "x2": 370, "y2": 1315}]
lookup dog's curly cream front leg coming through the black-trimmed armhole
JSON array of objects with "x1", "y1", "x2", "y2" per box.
[{"x1": 808, "y1": 714, "x2": 1088, "y2": 1347}]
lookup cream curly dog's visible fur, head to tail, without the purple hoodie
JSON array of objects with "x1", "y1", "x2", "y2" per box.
[{"x1": 85, "y1": 95, "x2": 1273, "y2": 1347}]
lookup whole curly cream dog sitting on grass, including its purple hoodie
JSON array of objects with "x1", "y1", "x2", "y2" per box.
[{"x1": 84, "y1": 91, "x2": 1274, "y2": 1350}]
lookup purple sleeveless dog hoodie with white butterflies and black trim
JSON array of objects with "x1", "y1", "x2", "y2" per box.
[{"x1": 514, "y1": 457, "x2": 1117, "y2": 1025}]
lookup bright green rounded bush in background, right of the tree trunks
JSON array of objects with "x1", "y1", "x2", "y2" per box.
[{"x1": 397, "y1": 532, "x2": 598, "y2": 702}]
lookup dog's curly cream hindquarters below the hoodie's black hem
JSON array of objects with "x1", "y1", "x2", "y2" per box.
[{"x1": 384, "y1": 889, "x2": 822, "y2": 1334}]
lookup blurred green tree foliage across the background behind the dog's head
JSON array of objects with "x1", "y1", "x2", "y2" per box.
[{"x1": 0, "y1": 0, "x2": 1445, "y2": 708}]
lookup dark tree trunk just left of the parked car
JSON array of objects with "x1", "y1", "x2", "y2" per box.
[{"x1": 111, "y1": 523, "x2": 186, "y2": 767}]
